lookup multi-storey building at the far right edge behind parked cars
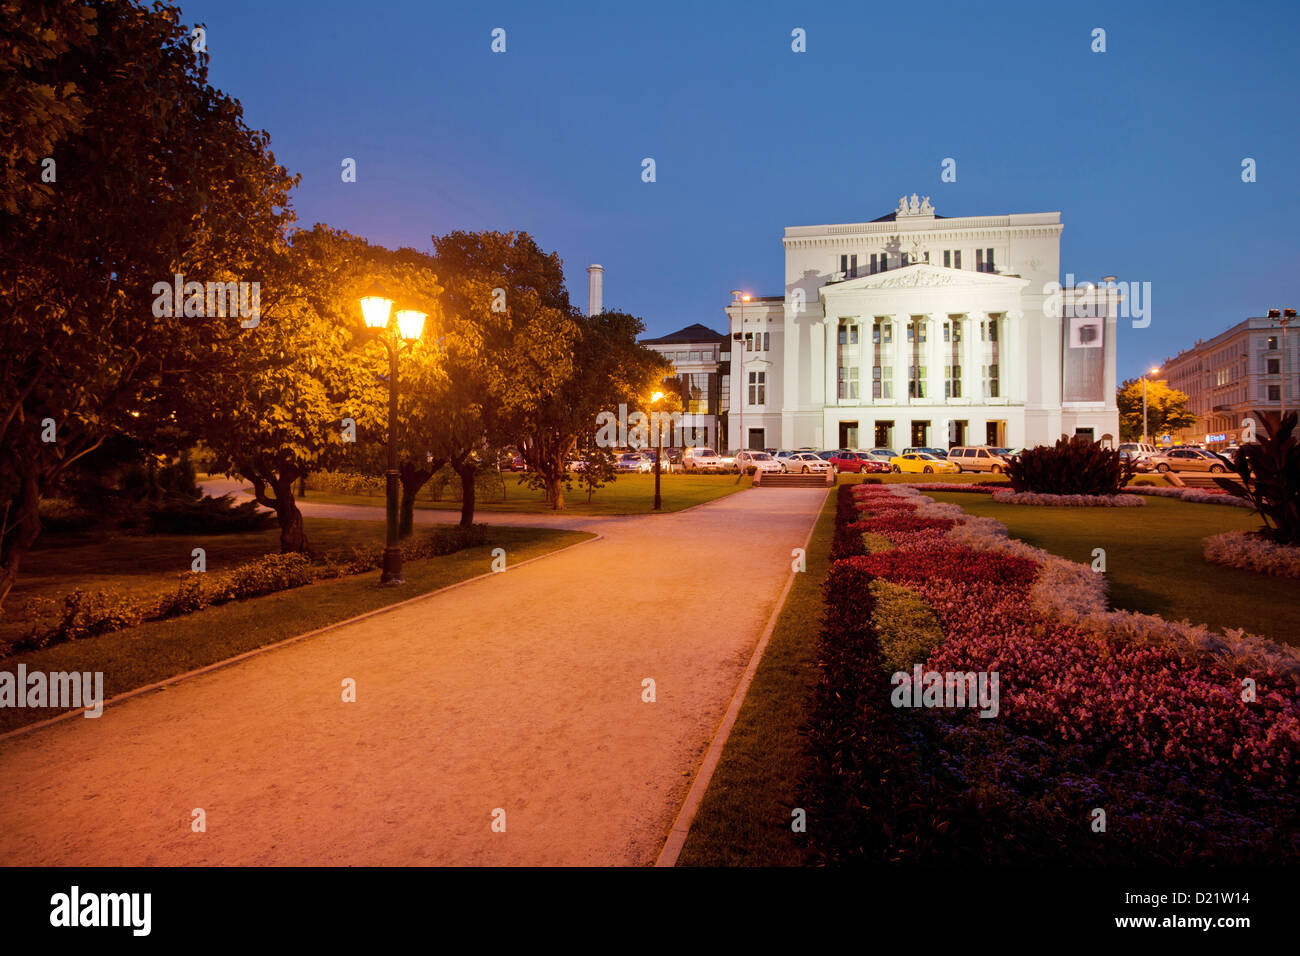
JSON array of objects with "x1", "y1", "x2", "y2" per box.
[{"x1": 1160, "y1": 316, "x2": 1300, "y2": 449}]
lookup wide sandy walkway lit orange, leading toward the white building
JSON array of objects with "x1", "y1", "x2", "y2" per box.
[{"x1": 0, "y1": 489, "x2": 826, "y2": 865}]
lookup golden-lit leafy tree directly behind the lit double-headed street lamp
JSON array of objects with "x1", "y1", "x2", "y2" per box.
[{"x1": 191, "y1": 225, "x2": 441, "y2": 551}]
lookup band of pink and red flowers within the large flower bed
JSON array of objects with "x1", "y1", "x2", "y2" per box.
[{"x1": 846, "y1": 486, "x2": 1300, "y2": 787}]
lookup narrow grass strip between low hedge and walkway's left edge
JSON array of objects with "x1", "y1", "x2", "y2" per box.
[{"x1": 0, "y1": 519, "x2": 593, "y2": 732}]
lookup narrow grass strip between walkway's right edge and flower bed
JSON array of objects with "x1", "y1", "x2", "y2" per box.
[{"x1": 677, "y1": 493, "x2": 835, "y2": 866}]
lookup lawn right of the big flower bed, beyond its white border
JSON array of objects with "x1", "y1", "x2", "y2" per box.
[{"x1": 927, "y1": 492, "x2": 1300, "y2": 645}]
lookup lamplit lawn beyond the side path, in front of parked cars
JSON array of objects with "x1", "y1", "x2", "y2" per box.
[{"x1": 303, "y1": 475, "x2": 750, "y2": 515}]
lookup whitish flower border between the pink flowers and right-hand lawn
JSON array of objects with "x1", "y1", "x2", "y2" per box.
[{"x1": 889, "y1": 485, "x2": 1300, "y2": 680}]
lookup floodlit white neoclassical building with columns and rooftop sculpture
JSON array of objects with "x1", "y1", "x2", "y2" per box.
[{"x1": 725, "y1": 195, "x2": 1119, "y2": 450}]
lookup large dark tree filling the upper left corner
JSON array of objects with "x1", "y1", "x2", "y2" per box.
[{"x1": 0, "y1": 0, "x2": 296, "y2": 602}]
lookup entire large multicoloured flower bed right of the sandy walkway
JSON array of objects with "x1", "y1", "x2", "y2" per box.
[{"x1": 807, "y1": 485, "x2": 1300, "y2": 864}]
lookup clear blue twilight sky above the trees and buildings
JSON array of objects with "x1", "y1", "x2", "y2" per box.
[{"x1": 179, "y1": 0, "x2": 1300, "y2": 378}]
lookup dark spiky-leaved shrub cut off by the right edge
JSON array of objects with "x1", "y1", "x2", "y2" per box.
[{"x1": 1214, "y1": 411, "x2": 1300, "y2": 545}]
